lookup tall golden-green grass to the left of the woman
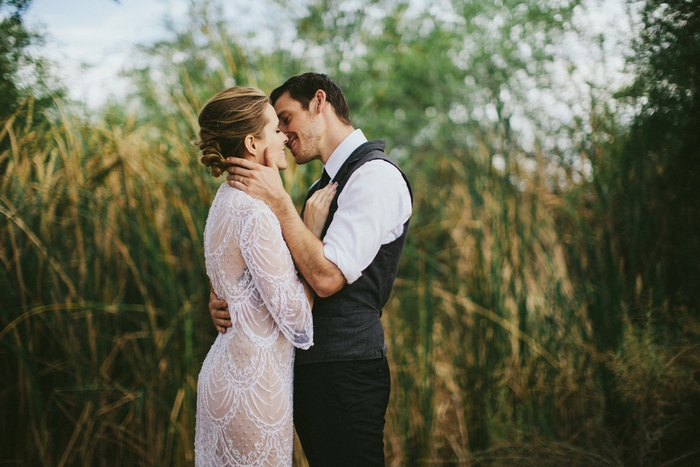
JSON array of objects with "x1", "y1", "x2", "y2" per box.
[{"x1": 0, "y1": 96, "x2": 213, "y2": 465}]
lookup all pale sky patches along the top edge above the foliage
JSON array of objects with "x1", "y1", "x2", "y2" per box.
[{"x1": 25, "y1": 0, "x2": 636, "y2": 108}]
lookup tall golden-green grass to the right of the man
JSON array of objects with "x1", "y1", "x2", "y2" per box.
[{"x1": 387, "y1": 126, "x2": 603, "y2": 465}]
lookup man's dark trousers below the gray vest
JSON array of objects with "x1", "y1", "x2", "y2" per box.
[{"x1": 294, "y1": 357, "x2": 391, "y2": 467}]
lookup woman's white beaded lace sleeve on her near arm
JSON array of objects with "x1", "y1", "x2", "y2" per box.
[{"x1": 238, "y1": 203, "x2": 313, "y2": 349}]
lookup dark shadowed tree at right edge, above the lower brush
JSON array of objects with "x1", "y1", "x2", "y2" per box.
[{"x1": 611, "y1": 0, "x2": 700, "y2": 317}]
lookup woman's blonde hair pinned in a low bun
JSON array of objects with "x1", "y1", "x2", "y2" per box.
[{"x1": 195, "y1": 86, "x2": 270, "y2": 177}]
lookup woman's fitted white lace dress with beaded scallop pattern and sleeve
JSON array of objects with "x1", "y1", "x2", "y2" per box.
[{"x1": 195, "y1": 183, "x2": 313, "y2": 467}]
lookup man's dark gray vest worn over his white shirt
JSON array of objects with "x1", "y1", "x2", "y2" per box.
[{"x1": 295, "y1": 141, "x2": 413, "y2": 365}]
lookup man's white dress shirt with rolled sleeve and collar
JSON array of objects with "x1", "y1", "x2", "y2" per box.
[{"x1": 323, "y1": 129, "x2": 412, "y2": 284}]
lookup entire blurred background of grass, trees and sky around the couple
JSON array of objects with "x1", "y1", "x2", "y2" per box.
[{"x1": 0, "y1": 0, "x2": 700, "y2": 467}]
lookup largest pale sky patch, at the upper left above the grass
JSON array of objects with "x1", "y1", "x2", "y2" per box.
[{"x1": 25, "y1": 0, "x2": 189, "y2": 108}]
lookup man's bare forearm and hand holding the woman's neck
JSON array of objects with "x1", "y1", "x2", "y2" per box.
[{"x1": 226, "y1": 153, "x2": 346, "y2": 297}]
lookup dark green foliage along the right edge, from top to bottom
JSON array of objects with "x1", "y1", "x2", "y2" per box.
[{"x1": 588, "y1": 1, "x2": 700, "y2": 465}]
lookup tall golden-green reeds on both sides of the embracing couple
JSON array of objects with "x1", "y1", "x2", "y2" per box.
[{"x1": 0, "y1": 86, "x2": 636, "y2": 465}]
